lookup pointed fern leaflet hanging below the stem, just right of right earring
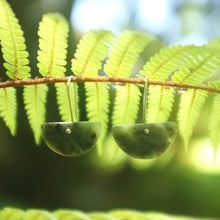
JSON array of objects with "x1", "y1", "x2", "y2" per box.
[{"x1": 178, "y1": 89, "x2": 208, "y2": 147}]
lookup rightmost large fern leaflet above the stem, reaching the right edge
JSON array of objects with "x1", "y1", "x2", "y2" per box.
[{"x1": 172, "y1": 45, "x2": 220, "y2": 85}]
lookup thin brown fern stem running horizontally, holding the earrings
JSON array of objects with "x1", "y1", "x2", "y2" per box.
[{"x1": 0, "y1": 76, "x2": 220, "y2": 93}]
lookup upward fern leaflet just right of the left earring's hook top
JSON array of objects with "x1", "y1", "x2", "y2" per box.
[{"x1": 72, "y1": 30, "x2": 114, "y2": 76}]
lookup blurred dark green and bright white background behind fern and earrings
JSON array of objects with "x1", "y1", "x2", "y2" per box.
[{"x1": 0, "y1": 0, "x2": 220, "y2": 218}]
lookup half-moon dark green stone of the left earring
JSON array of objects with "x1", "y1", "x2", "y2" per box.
[{"x1": 41, "y1": 121, "x2": 101, "y2": 157}]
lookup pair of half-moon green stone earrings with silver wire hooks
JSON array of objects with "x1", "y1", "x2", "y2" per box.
[{"x1": 41, "y1": 76, "x2": 177, "y2": 158}]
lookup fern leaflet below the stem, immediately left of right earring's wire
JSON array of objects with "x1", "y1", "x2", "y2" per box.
[{"x1": 112, "y1": 83, "x2": 141, "y2": 125}]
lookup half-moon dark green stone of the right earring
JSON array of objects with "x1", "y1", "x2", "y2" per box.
[{"x1": 112, "y1": 122, "x2": 177, "y2": 159}]
